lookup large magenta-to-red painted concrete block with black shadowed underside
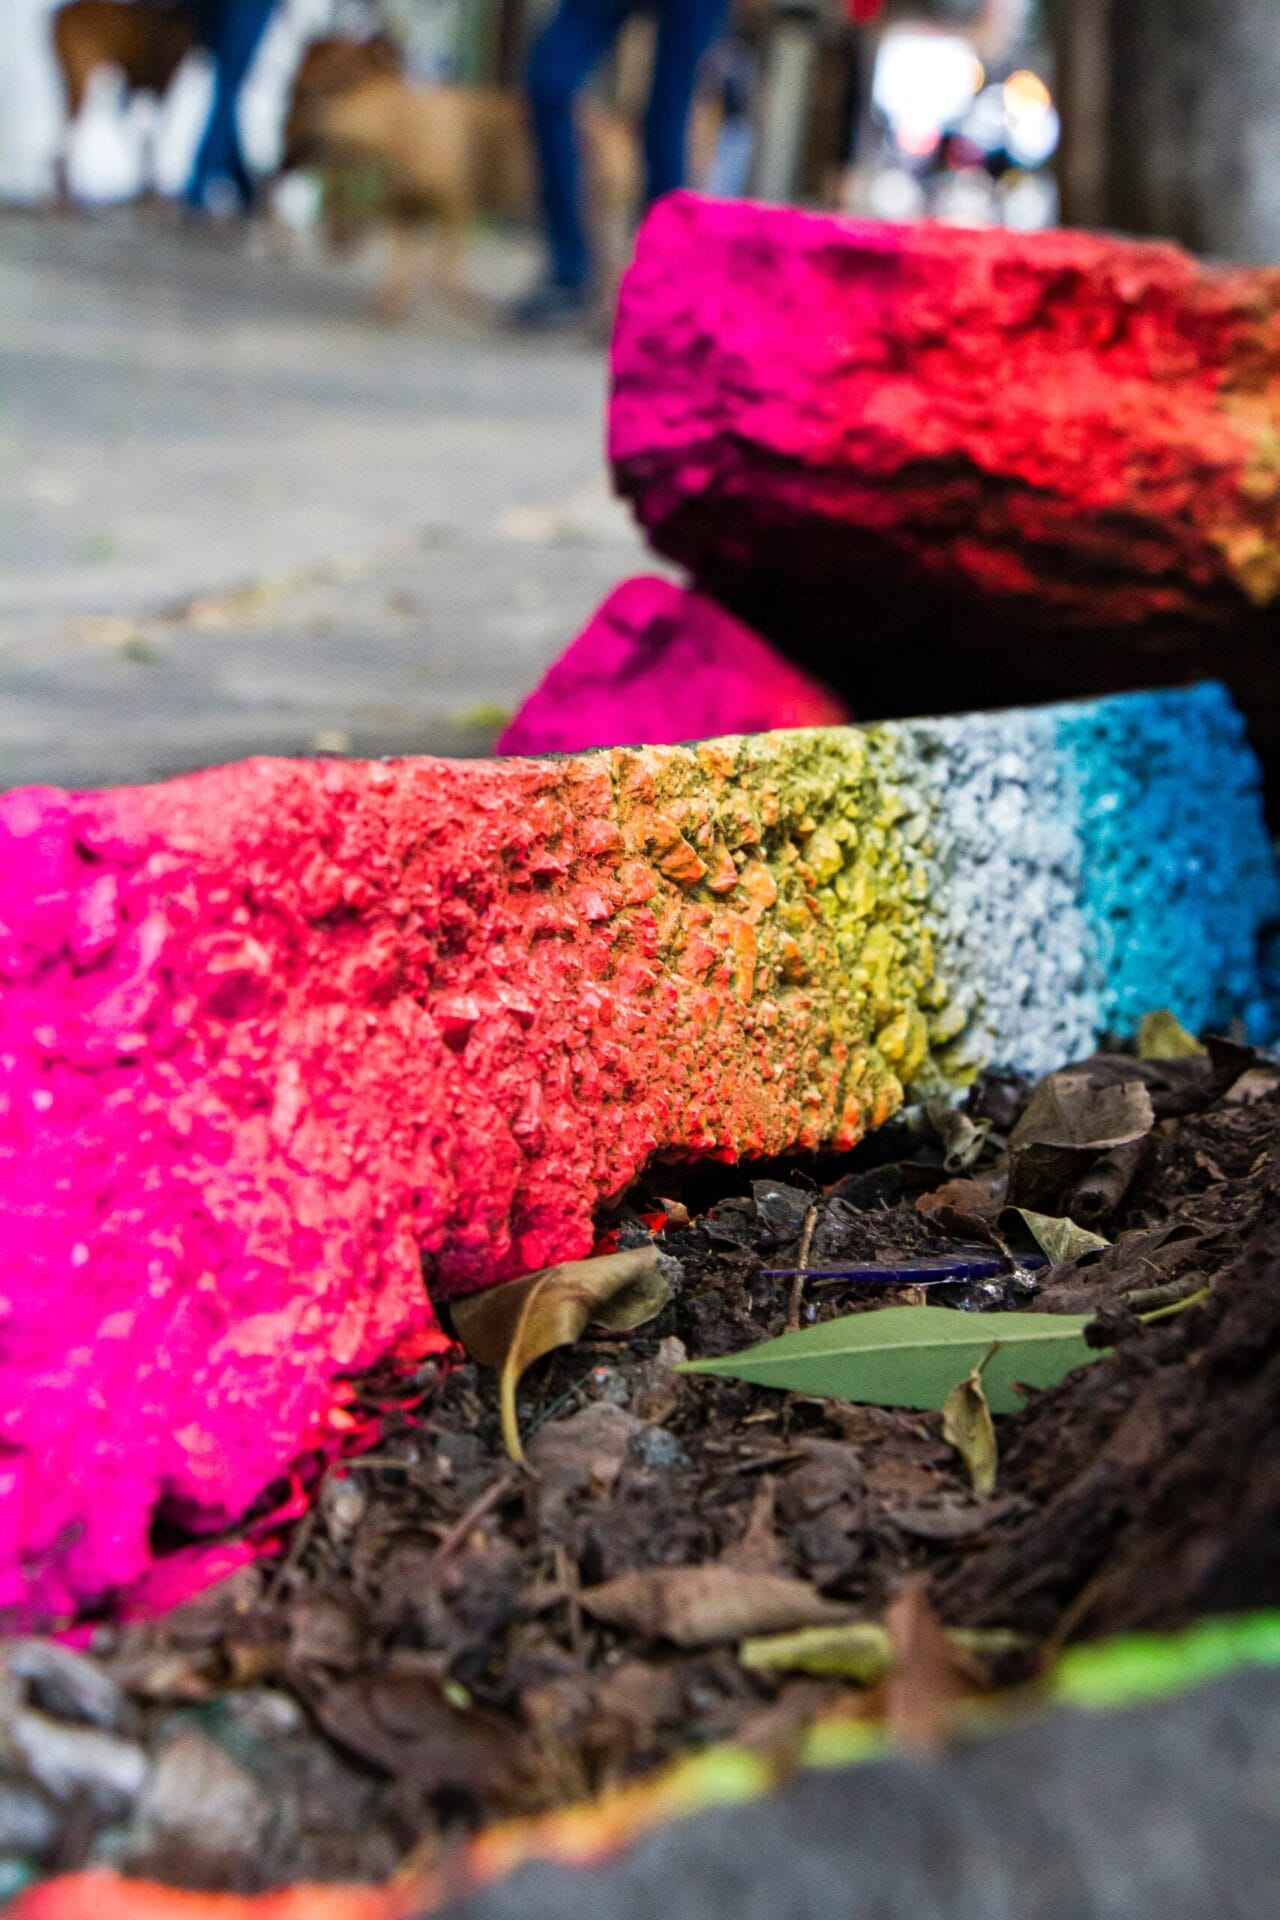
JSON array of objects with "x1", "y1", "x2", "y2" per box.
[{"x1": 610, "y1": 194, "x2": 1280, "y2": 756}]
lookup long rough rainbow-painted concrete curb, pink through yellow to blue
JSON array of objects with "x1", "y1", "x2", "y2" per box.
[{"x1": 0, "y1": 687, "x2": 1276, "y2": 1619}]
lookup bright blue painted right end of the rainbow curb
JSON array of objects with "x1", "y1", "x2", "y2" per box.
[{"x1": 1055, "y1": 685, "x2": 1280, "y2": 1041}]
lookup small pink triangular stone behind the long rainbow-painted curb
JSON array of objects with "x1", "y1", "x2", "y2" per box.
[{"x1": 497, "y1": 576, "x2": 850, "y2": 753}]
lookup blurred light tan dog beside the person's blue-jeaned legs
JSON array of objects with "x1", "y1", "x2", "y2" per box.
[{"x1": 284, "y1": 36, "x2": 639, "y2": 319}]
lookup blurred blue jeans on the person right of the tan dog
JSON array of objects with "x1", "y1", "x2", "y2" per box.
[{"x1": 530, "y1": 0, "x2": 729, "y2": 288}]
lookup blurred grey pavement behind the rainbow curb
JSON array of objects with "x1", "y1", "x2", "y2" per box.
[{"x1": 0, "y1": 213, "x2": 645, "y2": 787}]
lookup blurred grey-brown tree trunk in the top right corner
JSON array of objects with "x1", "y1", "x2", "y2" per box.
[{"x1": 1052, "y1": 0, "x2": 1280, "y2": 261}]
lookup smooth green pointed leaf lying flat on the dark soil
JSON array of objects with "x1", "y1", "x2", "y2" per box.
[{"x1": 679, "y1": 1308, "x2": 1098, "y2": 1413}]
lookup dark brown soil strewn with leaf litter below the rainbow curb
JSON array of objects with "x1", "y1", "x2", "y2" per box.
[{"x1": 10, "y1": 1043, "x2": 1280, "y2": 1889}]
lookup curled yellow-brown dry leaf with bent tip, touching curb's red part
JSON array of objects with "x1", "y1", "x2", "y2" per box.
[{"x1": 453, "y1": 1246, "x2": 676, "y2": 1463}]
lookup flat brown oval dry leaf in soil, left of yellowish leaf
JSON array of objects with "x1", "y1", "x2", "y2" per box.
[{"x1": 581, "y1": 1565, "x2": 848, "y2": 1647}]
